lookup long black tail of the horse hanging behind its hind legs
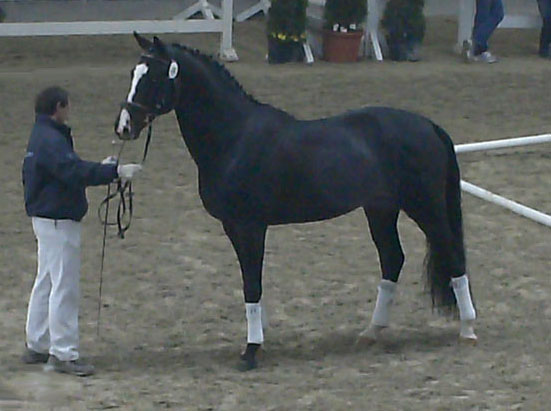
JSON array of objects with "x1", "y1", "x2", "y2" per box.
[{"x1": 426, "y1": 124, "x2": 466, "y2": 314}]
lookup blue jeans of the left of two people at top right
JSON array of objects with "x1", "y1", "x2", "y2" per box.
[{"x1": 473, "y1": 0, "x2": 504, "y2": 54}]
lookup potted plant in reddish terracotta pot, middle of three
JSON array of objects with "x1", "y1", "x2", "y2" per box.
[{"x1": 323, "y1": 0, "x2": 367, "y2": 62}]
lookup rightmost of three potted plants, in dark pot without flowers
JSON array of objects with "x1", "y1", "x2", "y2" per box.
[{"x1": 381, "y1": 0, "x2": 425, "y2": 61}]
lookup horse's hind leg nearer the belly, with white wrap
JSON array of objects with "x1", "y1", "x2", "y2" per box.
[{"x1": 361, "y1": 207, "x2": 404, "y2": 341}]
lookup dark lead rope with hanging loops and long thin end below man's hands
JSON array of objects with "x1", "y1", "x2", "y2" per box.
[{"x1": 96, "y1": 122, "x2": 153, "y2": 337}]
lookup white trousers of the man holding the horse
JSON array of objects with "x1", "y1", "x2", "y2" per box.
[{"x1": 25, "y1": 217, "x2": 81, "y2": 361}]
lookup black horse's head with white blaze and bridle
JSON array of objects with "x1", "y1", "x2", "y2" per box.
[{"x1": 115, "y1": 32, "x2": 180, "y2": 140}]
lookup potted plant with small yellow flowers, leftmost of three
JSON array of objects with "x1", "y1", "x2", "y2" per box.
[{"x1": 267, "y1": 0, "x2": 308, "y2": 63}]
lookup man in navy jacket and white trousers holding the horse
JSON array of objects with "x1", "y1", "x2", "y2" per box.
[{"x1": 22, "y1": 86, "x2": 141, "y2": 376}]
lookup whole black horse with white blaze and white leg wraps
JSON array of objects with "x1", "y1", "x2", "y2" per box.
[{"x1": 115, "y1": 33, "x2": 476, "y2": 368}]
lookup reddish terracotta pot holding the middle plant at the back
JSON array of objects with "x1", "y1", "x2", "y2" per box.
[{"x1": 323, "y1": 30, "x2": 363, "y2": 63}]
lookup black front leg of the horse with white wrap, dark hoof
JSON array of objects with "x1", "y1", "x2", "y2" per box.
[{"x1": 223, "y1": 221, "x2": 267, "y2": 370}]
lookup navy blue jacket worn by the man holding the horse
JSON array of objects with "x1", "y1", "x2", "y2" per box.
[{"x1": 23, "y1": 114, "x2": 118, "y2": 221}]
